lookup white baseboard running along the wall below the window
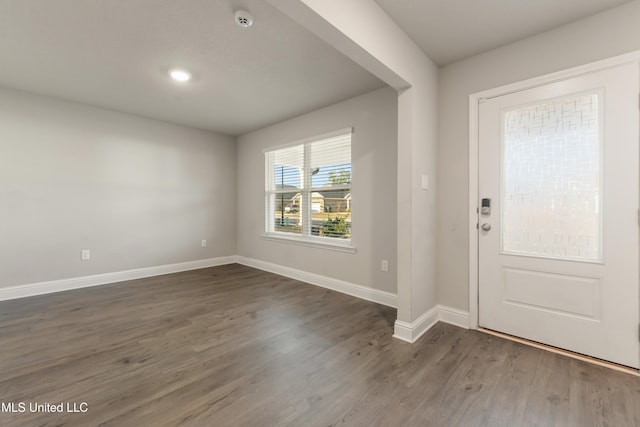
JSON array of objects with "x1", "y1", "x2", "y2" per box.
[{"x1": 237, "y1": 256, "x2": 398, "y2": 308}]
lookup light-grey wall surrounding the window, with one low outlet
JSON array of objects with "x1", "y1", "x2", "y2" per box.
[{"x1": 237, "y1": 88, "x2": 397, "y2": 293}]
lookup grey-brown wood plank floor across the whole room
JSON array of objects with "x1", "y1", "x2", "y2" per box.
[{"x1": 0, "y1": 265, "x2": 640, "y2": 427}]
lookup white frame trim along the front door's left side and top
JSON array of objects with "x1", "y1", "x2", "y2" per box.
[{"x1": 469, "y1": 50, "x2": 640, "y2": 329}]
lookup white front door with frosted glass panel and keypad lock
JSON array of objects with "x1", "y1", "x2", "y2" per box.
[{"x1": 478, "y1": 63, "x2": 640, "y2": 368}]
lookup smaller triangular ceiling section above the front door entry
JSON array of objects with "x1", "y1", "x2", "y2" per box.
[{"x1": 375, "y1": 0, "x2": 630, "y2": 66}]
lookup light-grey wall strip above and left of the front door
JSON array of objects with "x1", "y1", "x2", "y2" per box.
[{"x1": 437, "y1": 1, "x2": 640, "y2": 310}]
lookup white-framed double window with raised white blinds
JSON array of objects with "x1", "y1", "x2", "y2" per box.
[{"x1": 265, "y1": 129, "x2": 351, "y2": 243}]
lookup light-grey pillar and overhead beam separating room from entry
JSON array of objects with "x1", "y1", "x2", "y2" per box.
[{"x1": 268, "y1": 0, "x2": 438, "y2": 332}]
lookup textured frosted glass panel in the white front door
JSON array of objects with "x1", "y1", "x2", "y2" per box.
[{"x1": 502, "y1": 93, "x2": 602, "y2": 261}]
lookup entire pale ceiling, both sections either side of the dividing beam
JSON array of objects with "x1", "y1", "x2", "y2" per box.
[{"x1": 0, "y1": 0, "x2": 627, "y2": 135}]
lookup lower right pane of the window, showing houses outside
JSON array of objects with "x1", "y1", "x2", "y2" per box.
[{"x1": 311, "y1": 189, "x2": 351, "y2": 239}]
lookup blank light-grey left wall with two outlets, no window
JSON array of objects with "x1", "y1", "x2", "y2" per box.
[{"x1": 0, "y1": 89, "x2": 236, "y2": 287}]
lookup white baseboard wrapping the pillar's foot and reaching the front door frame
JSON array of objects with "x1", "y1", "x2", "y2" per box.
[{"x1": 393, "y1": 305, "x2": 469, "y2": 343}]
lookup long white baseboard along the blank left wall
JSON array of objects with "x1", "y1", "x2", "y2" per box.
[{"x1": 0, "y1": 255, "x2": 237, "y2": 301}]
